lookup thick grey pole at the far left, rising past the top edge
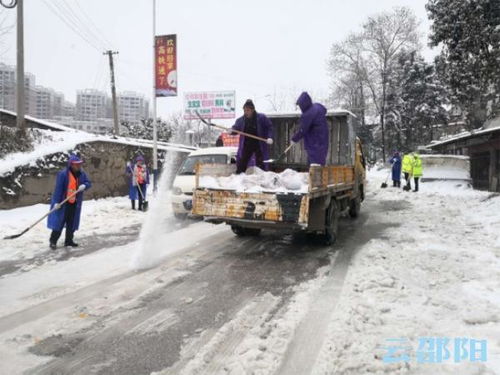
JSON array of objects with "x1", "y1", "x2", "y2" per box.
[{"x1": 0, "y1": 0, "x2": 26, "y2": 133}]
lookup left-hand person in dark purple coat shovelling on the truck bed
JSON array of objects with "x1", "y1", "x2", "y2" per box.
[{"x1": 233, "y1": 99, "x2": 273, "y2": 174}]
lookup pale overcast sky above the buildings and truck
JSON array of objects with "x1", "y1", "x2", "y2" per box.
[{"x1": 0, "y1": 0, "x2": 435, "y2": 120}]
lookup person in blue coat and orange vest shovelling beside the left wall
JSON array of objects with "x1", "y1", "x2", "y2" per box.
[{"x1": 47, "y1": 155, "x2": 91, "y2": 250}]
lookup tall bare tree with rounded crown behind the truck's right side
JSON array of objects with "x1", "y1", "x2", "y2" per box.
[{"x1": 329, "y1": 7, "x2": 421, "y2": 160}]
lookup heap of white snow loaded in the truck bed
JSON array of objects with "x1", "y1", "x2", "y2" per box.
[{"x1": 199, "y1": 168, "x2": 309, "y2": 194}]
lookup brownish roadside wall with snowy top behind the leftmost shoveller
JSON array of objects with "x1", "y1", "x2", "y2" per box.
[{"x1": 0, "y1": 141, "x2": 186, "y2": 209}]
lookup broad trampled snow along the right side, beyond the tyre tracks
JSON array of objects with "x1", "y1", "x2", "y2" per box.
[{"x1": 312, "y1": 171, "x2": 500, "y2": 375}]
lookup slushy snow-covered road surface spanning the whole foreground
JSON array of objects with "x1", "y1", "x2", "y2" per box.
[{"x1": 0, "y1": 172, "x2": 500, "y2": 375}]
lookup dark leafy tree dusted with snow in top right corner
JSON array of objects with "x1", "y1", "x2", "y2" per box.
[{"x1": 426, "y1": 0, "x2": 500, "y2": 128}]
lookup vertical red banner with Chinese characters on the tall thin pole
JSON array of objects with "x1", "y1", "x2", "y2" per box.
[{"x1": 155, "y1": 34, "x2": 177, "y2": 97}]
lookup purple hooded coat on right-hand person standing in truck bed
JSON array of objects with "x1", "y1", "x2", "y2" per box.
[{"x1": 292, "y1": 91, "x2": 329, "y2": 165}]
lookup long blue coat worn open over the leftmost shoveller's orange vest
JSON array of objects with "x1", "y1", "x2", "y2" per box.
[{"x1": 47, "y1": 155, "x2": 91, "y2": 231}]
